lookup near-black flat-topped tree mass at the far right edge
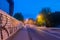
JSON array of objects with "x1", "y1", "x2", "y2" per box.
[{"x1": 51, "y1": 12, "x2": 60, "y2": 26}]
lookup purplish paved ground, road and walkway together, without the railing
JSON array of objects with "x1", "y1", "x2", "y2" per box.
[{"x1": 8, "y1": 27, "x2": 60, "y2": 40}]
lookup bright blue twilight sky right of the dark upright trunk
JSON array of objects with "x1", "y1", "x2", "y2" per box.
[{"x1": 14, "y1": 0, "x2": 60, "y2": 19}]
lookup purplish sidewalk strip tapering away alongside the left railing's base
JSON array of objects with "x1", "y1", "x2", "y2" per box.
[{"x1": 7, "y1": 28, "x2": 29, "y2": 40}]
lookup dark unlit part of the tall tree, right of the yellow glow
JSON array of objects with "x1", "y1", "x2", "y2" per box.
[{"x1": 41, "y1": 8, "x2": 51, "y2": 26}]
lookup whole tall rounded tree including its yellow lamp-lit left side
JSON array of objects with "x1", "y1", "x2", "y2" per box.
[{"x1": 37, "y1": 8, "x2": 51, "y2": 26}]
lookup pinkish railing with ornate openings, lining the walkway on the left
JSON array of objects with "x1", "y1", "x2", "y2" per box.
[{"x1": 0, "y1": 10, "x2": 22, "y2": 40}]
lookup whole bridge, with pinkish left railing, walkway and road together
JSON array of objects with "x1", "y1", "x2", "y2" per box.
[{"x1": 0, "y1": 10, "x2": 60, "y2": 40}]
